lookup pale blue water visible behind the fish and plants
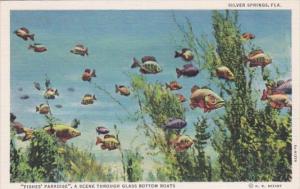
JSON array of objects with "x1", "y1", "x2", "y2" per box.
[{"x1": 11, "y1": 10, "x2": 291, "y2": 174}]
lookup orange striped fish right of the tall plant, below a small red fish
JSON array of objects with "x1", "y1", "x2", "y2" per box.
[{"x1": 247, "y1": 50, "x2": 272, "y2": 67}]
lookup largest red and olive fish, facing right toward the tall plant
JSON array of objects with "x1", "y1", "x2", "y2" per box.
[{"x1": 190, "y1": 85, "x2": 225, "y2": 112}]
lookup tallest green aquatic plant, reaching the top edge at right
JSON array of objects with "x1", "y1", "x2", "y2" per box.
[{"x1": 181, "y1": 11, "x2": 291, "y2": 181}]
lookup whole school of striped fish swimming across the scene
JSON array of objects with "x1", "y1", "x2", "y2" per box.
[{"x1": 10, "y1": 27, "x2": 292, "y2": 152}]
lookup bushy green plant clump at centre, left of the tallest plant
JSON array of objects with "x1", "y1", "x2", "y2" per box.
[{"x1": 131, "y1": 75, "x2": 209, "y2": 181}]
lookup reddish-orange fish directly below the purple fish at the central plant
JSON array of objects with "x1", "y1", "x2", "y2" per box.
[{"x1": 169, "y1": 135, "x2": 194, "y2": 152}]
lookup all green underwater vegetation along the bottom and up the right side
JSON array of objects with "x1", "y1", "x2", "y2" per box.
[{"x1": 10, "y1": 11, "x2": 291, "y2": 182}]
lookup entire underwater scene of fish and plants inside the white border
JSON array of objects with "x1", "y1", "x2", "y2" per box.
[{"x1": 10, "y1": 10, "x2": 292, "y2": 182}]
